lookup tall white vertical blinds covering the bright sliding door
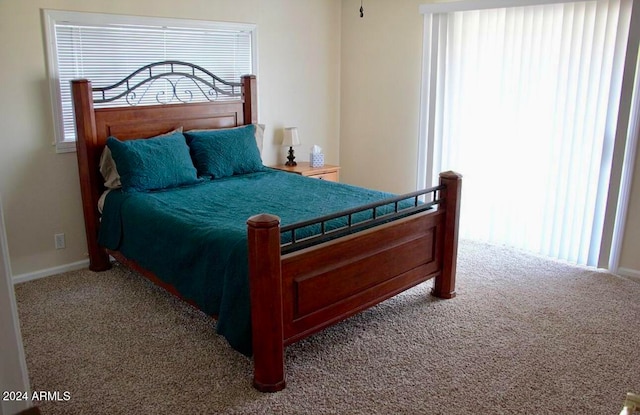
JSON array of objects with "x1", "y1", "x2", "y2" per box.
[{"x1": 420, "y1": 0, "x2": 630, "y2": 265}]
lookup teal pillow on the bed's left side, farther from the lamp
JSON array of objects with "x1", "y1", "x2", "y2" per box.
[{"x1": 107, "y1": 132, "x2": 198, "y2": 192}]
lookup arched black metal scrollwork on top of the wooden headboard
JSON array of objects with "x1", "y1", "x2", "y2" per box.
[{"x1": 92, "y1": 61, "x2": 242, "y2": 106}]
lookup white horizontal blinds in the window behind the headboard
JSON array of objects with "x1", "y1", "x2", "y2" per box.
[{"x1": 49, "y1": 17, "x2": 252, "y2": 146}]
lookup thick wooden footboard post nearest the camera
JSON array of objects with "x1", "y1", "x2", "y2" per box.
[{"x1": 247, "y1": 214, "x2": 285, "y2": 392}]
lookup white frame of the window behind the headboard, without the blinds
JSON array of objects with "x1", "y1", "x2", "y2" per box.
[{"x1": 42, "y1": 9, "x2": 258, "y2": 153}]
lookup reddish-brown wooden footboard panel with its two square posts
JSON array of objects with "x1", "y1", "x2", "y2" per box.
[{"x1": 247, "y1": 172, "x2": 461, "y2": 392}]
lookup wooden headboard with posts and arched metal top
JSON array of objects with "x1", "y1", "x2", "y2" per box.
[{"x1": 71, "y1": 61, "x2": 258, "y2": 271}]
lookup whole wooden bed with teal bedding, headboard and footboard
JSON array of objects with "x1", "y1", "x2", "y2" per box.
[{"x1": 72, "y1": 61, "x2": 461, "y2": 392}]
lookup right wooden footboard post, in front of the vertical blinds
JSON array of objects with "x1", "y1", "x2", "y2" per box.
[{"x1": 432, "y1": 171, "x2": 462, "y2": 298}]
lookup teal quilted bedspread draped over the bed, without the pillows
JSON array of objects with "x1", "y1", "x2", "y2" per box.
[{"x1": 99, "y1": 169, "x2": 404, "y2": 356}]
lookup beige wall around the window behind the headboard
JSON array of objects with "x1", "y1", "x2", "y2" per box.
[{"x1": 0, "y1": 0, "x2": 341, "y2": 276}]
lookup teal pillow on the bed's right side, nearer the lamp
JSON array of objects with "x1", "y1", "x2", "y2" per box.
[{"x1": 184, "y1": 124, "x2": 264, "y2": 179}]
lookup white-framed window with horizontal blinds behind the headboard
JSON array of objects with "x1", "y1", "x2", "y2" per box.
[{"x1": 44, "y1": 10, "x2": 256, "y2": 152}]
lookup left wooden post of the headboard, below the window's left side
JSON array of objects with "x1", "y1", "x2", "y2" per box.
[{"x1": 71, "y1": 79, "x2": 111, "y2": 271}]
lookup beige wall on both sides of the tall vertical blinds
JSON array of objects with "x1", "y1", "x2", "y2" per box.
[{"x1": 340, "y1": 0, "x2": 640, "y2": 275}]
